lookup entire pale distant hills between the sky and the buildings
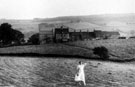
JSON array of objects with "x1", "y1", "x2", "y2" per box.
[{"x1": 0, "y1": 14, "x2": 135, "y2": 38}]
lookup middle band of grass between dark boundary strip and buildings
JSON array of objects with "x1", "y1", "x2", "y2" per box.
[{"x1": 0, "y1": 39, "x2": 135, "y2": 61}]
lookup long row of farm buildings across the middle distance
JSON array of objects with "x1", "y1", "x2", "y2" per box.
[{"x1": 39, "y1": 23, "x2": 120, "y2": 44}]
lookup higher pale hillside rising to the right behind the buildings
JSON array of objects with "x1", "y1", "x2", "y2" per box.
[{"x1": 34, "y1": 14, "x2": 135, "y2": 36}]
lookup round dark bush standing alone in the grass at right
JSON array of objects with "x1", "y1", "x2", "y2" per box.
[{"x1": 93, "y1": 46, "x2": 109, "y2": 59}]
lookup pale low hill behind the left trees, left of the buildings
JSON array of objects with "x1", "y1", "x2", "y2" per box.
[{"x1": 0, "y1": 19, "x2": 39, "y2": 39}]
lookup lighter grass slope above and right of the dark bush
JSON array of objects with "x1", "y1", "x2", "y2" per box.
[{"x1": 68, "y1": 39, "x2": 135, "y2": 60}]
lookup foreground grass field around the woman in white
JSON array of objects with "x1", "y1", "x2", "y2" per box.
[{"x1": 0, "y1": 57, "x2": 135, "y2": 87}]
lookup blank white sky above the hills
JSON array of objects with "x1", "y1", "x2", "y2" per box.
[{"x1": 0, "y1": 0, "x2": 135, "y2": 19}]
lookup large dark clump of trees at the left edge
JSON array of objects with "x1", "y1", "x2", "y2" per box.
[{"x1": 0, "y1": 23, "x2": 24, "y2": 45}]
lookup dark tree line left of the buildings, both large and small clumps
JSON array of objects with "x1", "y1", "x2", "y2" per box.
[{"x1": 0, "y1": 23, "x2": 39, "y2": 46}]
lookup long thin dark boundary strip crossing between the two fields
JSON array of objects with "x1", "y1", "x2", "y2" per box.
[{"x1": 0, "y1": 53, "x2": 135, "y2": 63}]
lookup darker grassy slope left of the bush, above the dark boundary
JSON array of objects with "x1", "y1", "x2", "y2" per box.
[{"x1": 0, "y1": 44, "x2": 93, "y2": 57}]
